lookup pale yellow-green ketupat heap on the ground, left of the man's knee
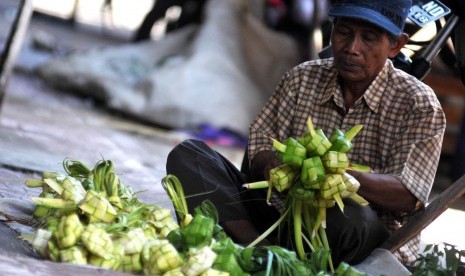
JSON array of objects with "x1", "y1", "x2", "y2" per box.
[{"x1": 26, "y1": 159, "x2": 183, "y2": 274}]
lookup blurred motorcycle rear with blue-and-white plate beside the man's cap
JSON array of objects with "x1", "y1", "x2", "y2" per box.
[{"x1": 394, "y1": 0, "x2": 465, "y2": 84}]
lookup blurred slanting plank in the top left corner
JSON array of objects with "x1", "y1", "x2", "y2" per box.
[{"x1": 0, "y1": 0, "x2": 32, "y2": 107}]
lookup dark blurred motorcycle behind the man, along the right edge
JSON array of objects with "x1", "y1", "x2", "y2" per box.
[{"x1": 397, "y1": 0, "x2": 465, "y2": 181}]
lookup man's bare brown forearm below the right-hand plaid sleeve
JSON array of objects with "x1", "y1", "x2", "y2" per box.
[{"x1": 348, "y1": 171, "x2": 417, "y2": 212}]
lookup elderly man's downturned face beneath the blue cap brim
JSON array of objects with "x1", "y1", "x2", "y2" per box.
[{"x1": 331, "y1": 18, "x2": 397, "y2": 84}]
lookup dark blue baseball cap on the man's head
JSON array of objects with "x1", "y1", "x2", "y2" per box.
[{"x1": 328, "y1": 0, "x2": 412, "y2": 36}]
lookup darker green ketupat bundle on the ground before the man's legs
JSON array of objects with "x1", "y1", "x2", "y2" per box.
[{"x1": 162, "y1": 175, "x2": 365, "y2": 276}]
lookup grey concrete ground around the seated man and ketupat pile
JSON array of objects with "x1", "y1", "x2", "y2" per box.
[{"x1": 0, "y1": 2, "x2": 465, "y2": 275}]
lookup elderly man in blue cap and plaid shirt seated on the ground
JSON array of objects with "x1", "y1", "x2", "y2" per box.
[{"x1": 167, "y1": 0, "x2": 445, "y2": 264}]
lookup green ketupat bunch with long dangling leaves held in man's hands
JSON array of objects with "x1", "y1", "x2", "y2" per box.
[{"x1": 244, "y1": 118, "x2": 371, "y2": 272}]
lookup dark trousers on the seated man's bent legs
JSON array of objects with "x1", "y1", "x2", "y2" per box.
[{"x1": 166, "y1": 140, "x2": 389, "y2": 265}]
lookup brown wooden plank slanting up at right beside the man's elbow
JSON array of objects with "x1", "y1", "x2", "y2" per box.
[{"x1": 381, "y1": 175, "x2": 465, "y2": 252}]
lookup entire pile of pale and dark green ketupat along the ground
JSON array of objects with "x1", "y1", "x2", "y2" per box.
[{"x1": 26, "y1": 155, "x2": 364, "y2": 276}]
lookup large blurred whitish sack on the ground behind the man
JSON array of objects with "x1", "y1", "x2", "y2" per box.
[{"x1": 38, "y1": 0, "x2": 299, "y2": 134}]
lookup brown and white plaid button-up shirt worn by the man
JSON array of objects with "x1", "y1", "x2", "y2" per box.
[{"x1": 248, "y1": 59, "x2": 446, "y2": 263}]
